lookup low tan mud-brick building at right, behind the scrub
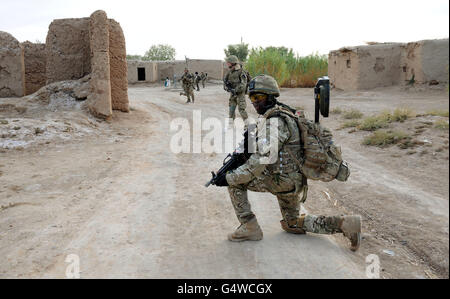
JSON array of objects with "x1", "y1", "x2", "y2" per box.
[{"x1": 328, "y1": 39, "x2": 449, "y2": 90}]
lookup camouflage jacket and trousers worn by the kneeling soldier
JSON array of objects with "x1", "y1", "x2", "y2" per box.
[{"x1": 226, "y1": 107, "x2": 342, "y2": 234}]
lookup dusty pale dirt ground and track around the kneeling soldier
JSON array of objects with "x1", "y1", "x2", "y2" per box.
[{"x1": 0, "y1": 85, "x2": 449, "y2": 278}]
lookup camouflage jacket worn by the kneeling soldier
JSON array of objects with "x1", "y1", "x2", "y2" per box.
[{"x1": 227, "y1": 107, "x2": 301, "y2": 186}]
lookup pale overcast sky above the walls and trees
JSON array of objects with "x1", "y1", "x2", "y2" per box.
[{"x1": 0, "y1": 0, "x2": 449, "y2": 59}]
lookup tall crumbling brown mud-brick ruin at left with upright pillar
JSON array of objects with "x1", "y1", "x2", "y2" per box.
[{"x1": 0, "y1": 10, "x2": 129, "y2": 118}]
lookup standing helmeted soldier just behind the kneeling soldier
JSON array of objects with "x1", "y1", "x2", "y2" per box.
[{"x1": 224, "y1": 55, "x2": 248, "y2": 124}]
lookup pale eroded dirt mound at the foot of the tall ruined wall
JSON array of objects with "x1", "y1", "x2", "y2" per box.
[{"x1": 0, "y1": 76, "x2": 109, "y2": 150}]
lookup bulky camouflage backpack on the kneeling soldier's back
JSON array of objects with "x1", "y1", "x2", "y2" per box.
[{"x1": 268, "y1": 108, "x2": 350, "y2": 182}]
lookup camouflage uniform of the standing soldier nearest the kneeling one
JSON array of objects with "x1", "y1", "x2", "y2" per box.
[{"x1": 224, "y1": 64, "x2": 248, "y2": 120}]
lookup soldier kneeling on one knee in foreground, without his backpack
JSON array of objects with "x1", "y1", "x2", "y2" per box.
[{"x1": 211, "y1": 75, "x2": 361, "y2": 251}]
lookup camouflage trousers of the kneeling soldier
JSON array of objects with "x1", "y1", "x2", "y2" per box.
[{"x1": 228, "y1": 174, "x2": 342, "y2": 234}]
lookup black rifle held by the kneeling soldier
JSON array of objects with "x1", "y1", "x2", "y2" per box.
[{"x1": 205, "y1": 126, "x2": 256, "y2": 188}]
